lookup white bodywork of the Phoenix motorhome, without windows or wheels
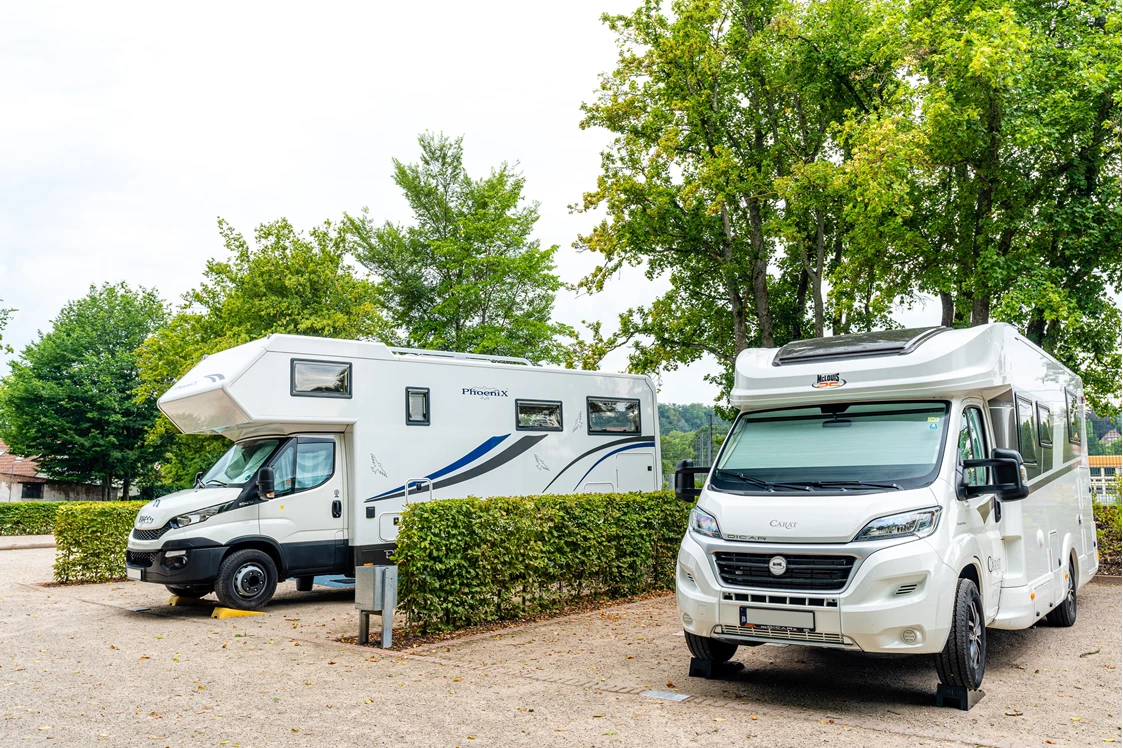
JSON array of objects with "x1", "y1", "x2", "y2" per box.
[{"x1": 129, "y1": 335, "x2": 663, "y2": 583}]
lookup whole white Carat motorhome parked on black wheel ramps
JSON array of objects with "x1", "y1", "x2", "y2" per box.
[{"x1": 675, "y1": 323, "x2": 1099, "y2": 690}]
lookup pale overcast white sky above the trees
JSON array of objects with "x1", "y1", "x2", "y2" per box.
[{"x1": 0, "y1": 0, "x2": 939, "y2": 402}]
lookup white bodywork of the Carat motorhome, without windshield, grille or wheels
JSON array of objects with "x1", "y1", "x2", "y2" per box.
[{"x1": 677, "y1": 325, "x2": 1098, "y2": 654}]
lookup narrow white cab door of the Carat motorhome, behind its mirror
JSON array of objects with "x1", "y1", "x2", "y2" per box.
[{"x1": 959, "y1": 401, "x2": 1006, "y2": 621}]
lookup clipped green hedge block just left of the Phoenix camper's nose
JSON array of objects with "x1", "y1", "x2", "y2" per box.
[{"x1": 55, "y1": 501, "x2": 145, "y2": 584}]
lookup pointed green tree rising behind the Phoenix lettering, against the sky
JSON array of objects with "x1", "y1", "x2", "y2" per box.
[{"x1": 346, "y1": 133, "x2": 572, "y2": 362}]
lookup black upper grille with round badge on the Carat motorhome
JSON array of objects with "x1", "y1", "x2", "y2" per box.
[{"x1": 713, "y1": 551, "x2": 855, "y2": 592}]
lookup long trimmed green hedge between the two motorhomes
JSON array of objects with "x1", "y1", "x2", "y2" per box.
[{"x1": 395, "y1": 492, "x2": 691, "y2": 631}]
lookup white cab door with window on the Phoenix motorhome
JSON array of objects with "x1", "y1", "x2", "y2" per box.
[{"x1": 258, "y1": 436, "x2": 347, "y2": 576}]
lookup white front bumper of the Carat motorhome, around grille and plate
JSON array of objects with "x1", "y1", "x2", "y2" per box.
[{"x1": 675, "y1": 532, "x2": 957, "y2": 654}]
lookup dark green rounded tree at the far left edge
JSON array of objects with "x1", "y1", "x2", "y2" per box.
[{"x1": 0, "y1": 283, "x2": 166, "y2": 499}]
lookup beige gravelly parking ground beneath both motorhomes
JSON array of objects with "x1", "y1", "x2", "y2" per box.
[{"x1": 0, "y1": 549, "x2": 1123, "y2": 748}]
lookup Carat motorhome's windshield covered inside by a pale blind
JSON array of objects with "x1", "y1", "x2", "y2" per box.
[{"x1": 711, "y1": 402, "x2": 948, "y2": 492}]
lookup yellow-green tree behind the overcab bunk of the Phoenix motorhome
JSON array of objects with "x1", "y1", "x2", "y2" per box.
[{"x1": 137, "y1": 219, "x2": 387, "y2": 485}]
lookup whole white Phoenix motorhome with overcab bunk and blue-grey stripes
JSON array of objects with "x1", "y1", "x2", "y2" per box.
[{"x1": 126, "y1": 335, "x2": 661, "y2": 610}]
